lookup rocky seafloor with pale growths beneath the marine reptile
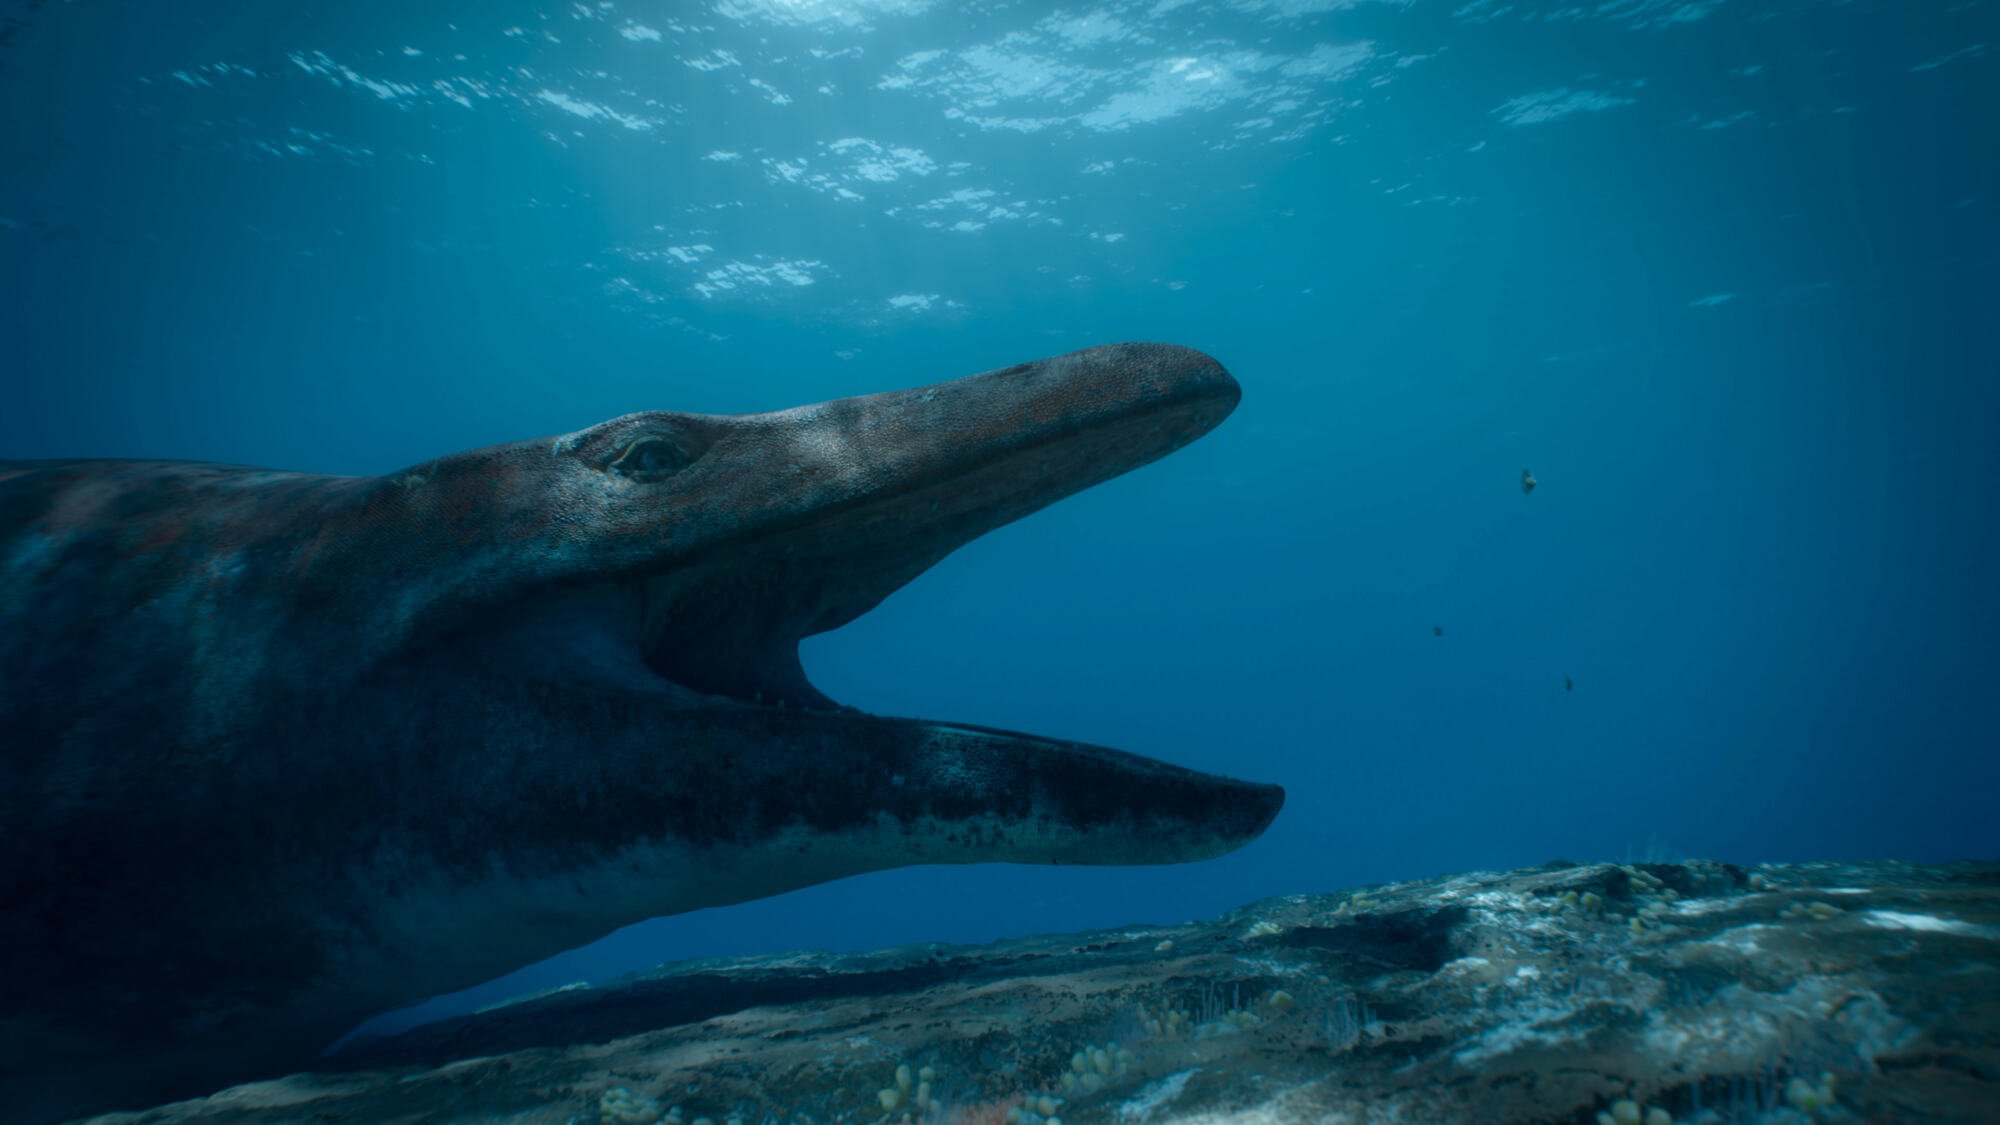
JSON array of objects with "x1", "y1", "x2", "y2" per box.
[{"x1": 86, "y1": 863, "x2": 2000, "y2": 1125}]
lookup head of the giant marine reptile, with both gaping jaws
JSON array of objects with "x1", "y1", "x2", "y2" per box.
[{"x1": 330, "y1": 344, "x2": 1284, "y2": 876}]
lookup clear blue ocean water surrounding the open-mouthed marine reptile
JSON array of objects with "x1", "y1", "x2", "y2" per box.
[{"x1": 0, "y1": 0, "x2": 2000, "y2": 1021}]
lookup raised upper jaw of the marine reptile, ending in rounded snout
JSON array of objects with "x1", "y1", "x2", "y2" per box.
[{"x1": 608, "y1": 344, "x2": 1240, "y2": 592}]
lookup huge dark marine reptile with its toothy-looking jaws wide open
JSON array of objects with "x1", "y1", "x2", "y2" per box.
[{"x1": 0, "y1": 344, "x2": 1282, "y2": 1121}]
